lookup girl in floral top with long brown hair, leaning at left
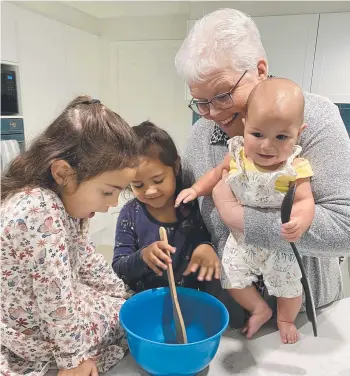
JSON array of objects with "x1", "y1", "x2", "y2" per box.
[{"x1": 0, "y1": 97, "x2": 136, "y2": 376}]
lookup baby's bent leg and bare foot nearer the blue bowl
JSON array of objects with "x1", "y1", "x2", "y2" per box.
[{"x1": 228, "y1": 286, "x2": 272, "y2": 338}]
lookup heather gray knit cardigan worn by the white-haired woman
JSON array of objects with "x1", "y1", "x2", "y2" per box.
[{"x1": 183, "y1": 93, "x2": 350, "y2": 307}]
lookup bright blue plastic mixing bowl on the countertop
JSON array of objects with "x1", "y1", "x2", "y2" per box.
[{"x1": 120, "y1": 287, "x2": 229, "y2": 376}]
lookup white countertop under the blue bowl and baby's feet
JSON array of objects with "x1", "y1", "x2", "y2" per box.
[{"x1": 106, "y1": 298, "x2": 350, "y2": 376}]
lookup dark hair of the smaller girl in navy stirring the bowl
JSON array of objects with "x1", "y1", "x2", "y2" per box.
[{"x1": 133, "y1": 121, "x2": 182, "y2": 197}]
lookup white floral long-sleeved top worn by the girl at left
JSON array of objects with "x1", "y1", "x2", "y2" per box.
[{"x1": 0, "y1": 188, "x2": 127, "y2": 376}]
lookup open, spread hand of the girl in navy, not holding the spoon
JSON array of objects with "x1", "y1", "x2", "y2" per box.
[{"x1": 183, "y1": 244, "x2": 220, "y2": 281}]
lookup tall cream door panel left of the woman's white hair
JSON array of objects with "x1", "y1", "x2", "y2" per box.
[{"x1": 111, "y1": 40, "x2": 192, "y2": 151}]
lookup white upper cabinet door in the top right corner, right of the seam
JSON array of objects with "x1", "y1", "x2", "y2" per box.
[{"x1": 312, "y1": 12, "x2": 350, "y2": 103}]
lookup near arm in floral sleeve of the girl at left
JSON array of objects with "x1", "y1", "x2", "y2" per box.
[{"x1": 20, "y1": 194, "x2": 85, "y2": 369}]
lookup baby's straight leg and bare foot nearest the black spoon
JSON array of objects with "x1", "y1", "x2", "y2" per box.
[{"x1": 277, "y1": 295, "x2": 302, "y2": 344}]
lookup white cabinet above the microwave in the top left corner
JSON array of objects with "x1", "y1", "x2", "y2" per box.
[{"x1": 1, "y1": 1, "x2": 18, "y2": 63}]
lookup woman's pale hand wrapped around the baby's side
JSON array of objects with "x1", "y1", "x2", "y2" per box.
[{"x1": 213, "y1": 170, "x2": 244, "y2": 232}]
